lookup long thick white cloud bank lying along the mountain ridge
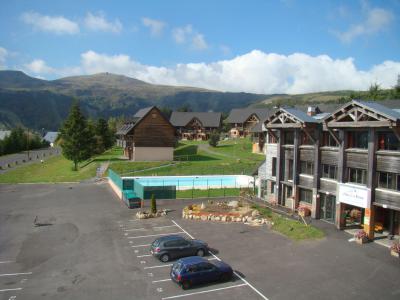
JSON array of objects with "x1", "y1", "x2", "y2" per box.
[{"x1": 22, "y1": 50, "x2": 400, "y2": 94}]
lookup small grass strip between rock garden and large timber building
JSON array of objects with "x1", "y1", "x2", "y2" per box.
[{"x1": 253, "y1": 205, "x2": 325, "y2": 241}]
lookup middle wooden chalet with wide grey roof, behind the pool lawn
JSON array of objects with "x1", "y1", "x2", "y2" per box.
[{"x1": 170, "y1": 111, "x2": 222, "y2": 140}]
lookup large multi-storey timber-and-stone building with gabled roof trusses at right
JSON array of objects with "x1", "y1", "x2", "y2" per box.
[{"x1": 260, "y1": 100, "x2": 400, "y2": 239}]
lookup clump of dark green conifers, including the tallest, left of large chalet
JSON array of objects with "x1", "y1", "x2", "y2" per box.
[{"x1": 57, "y1": 103, "x2": 117, "y2": 170}]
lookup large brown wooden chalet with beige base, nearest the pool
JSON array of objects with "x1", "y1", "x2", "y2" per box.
[{"x1": 117, "y1": 106, "x2": 176, "y2": 161}]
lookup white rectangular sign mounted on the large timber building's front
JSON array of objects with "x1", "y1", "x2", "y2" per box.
[{"x1": 337, "y1": 183, "x2": 371, "y2": 208}]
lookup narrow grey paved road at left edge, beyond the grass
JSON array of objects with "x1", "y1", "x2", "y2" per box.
[{"x1": 0, "y1": 148, "x2": 61, "y2": 173}]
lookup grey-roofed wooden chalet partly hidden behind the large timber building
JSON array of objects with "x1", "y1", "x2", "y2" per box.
[{"x1": 227, "y1": 108, "x2": 270, "y2": 138}]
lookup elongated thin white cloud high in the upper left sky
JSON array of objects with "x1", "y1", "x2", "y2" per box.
[{"x1": 21, "y1": 12, "x2": 79, "y2": 34}]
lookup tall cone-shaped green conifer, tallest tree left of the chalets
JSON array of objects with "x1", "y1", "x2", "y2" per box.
[{"x1": 60, "y1": 103, "x2": 93, "y2": 171}]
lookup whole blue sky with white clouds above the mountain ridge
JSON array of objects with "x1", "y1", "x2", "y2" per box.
[{"x1": 0, "y1": 0, "x2": 400, "y2": 94}]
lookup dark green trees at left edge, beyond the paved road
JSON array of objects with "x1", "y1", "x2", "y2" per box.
[{"x1": 0, "y1": 127, "x2": 49, "y2": 155}]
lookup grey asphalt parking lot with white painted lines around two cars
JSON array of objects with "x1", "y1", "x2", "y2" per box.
[{"x1": 0, "y1": 183, "x2": 400, "y2": 300}]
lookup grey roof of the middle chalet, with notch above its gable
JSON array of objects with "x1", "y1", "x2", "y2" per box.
[{"x1": 170, "y1": 111, "x2": 221, "y2": 127}]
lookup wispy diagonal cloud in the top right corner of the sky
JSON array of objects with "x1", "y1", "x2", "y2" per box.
[{"x1": 335, "y1": 7, "x2": 394, "y2": 43}]
